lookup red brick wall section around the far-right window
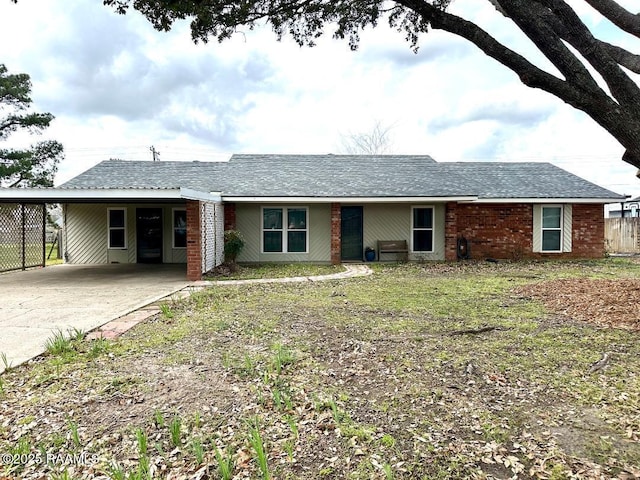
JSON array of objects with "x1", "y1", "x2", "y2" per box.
[{"x1": 445, "y1": 202, "x2": 604, "y2": 261}]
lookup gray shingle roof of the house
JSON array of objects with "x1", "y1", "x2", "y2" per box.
[{"x1": 60, "y1": 155, "x2": 623, "y2": 199}]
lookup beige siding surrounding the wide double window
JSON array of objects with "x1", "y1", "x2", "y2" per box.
[{"x1": 236, "y1": 204, "x2": 331, "y2": 263}]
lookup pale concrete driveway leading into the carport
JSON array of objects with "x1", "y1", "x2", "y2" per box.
[{"x1": 0, "y1": 264, "x2": 190, "y2": 372}]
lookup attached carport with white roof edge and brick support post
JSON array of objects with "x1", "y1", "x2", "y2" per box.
[{"x1": 0, "y1": 187, "x2": 224, "y2": 280}]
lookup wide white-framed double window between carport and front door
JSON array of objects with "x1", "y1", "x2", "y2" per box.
[{"x1": 262, "y1": 207, "x2": 308, "y2": 253}]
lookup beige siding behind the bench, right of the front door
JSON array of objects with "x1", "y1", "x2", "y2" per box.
[{"x1": 363, "y1": 204, "x2": 445, "y2": 260}]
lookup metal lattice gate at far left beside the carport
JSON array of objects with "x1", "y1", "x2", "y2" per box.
[{"x1": 0, "y1": 203, "x2": 47, "y2": 272}]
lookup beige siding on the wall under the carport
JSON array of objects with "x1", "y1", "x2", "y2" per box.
[{"x1": 65, "y1": 204, "x2": 187, "y2": 264}]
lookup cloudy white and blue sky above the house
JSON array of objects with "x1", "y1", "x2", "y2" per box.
[{"x1": 0, "y1": 0, "x2": 640, "y2": 196}]
